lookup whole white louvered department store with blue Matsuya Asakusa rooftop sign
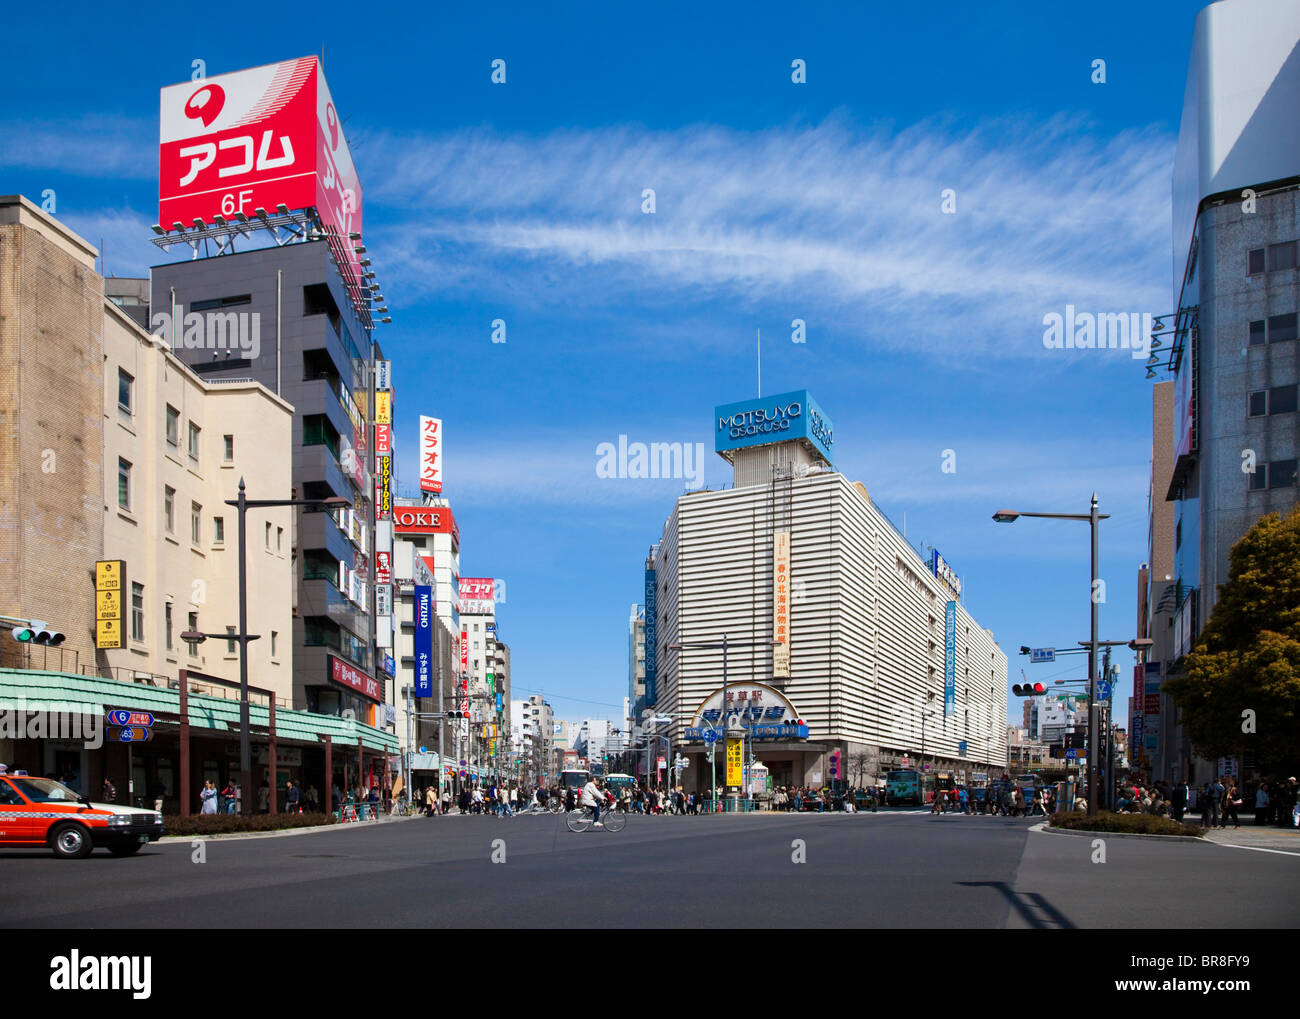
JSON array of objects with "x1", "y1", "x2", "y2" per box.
[{"x1": 654, "y1": 391, "x2": 1008, "y2": 790}]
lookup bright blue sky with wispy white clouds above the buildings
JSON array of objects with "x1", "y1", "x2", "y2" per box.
[{"x1": 0, "y1": 0, "x2": 1204, "y2": 719}]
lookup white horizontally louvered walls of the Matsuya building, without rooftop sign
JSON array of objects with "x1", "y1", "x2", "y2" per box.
[{"x1": 655, "y1": 471, "x2": 1006, "y2": 786}]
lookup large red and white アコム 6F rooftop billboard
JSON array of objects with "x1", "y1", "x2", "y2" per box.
[{"x1": 159, "y1": 57, "x2": 361, "y2": 283}]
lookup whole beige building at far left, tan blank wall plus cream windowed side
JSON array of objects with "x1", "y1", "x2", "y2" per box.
[{"x1": 0, "y1": 196, "x2": 294, "y2": 706}]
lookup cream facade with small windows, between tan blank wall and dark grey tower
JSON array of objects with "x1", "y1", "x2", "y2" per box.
[{"x1": 103, "y1": 302, "x2": 294, "y2": 707}]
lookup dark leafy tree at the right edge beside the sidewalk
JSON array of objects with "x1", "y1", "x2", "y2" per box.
[{"x1": 1166, "y1": 504, "x2": 1300, "y2": 772}]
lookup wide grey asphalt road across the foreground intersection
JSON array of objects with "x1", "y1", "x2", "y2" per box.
[{"x1": 0, "y1": 812, "x2": 1300, "y2": 929}]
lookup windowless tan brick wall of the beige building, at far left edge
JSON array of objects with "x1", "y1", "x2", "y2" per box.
[{"x1": 0, "y1": 195, "x2": 104, "y2": 669}]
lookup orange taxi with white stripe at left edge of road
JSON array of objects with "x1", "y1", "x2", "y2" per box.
[{"x1": 0, "y1": 775, "x2": 165, "y2": 859}]
